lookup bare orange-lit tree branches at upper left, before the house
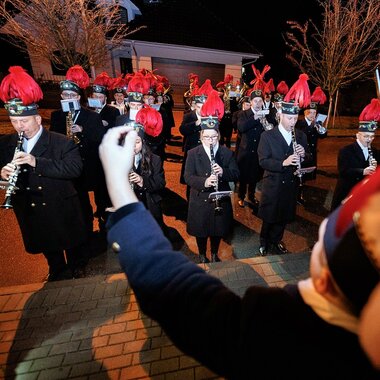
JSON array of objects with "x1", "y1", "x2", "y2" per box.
[{"x1": 0, "y1": 0, "x2": 145, "y2": 68}]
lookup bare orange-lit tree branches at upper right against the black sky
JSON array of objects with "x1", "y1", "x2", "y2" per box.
[{"x1": 284, "y1": 0, "x2": 380, "y2": 99}]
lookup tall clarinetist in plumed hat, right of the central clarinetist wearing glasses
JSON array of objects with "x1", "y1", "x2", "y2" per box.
[{"x1": 258, "y1": 74, "x2": 310, "y2": 256}]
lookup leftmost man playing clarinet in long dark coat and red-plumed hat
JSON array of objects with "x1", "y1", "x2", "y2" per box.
[{"x1": 0, "y1": 66, "x2": 89, "y2": 281}]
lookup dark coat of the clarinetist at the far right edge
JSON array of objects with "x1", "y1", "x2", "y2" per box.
[{"x1": 331, "y1": 141, "x2": 379, "y2": 211}]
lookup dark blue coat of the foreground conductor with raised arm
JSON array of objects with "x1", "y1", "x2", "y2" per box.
[{"x1": 108, "y1": 203, "x2": 379, "y2": 380}]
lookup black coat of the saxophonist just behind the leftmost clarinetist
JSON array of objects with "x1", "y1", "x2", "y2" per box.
[{"x1": 50, "y1": 108, "x2": 106, "y2": 190}]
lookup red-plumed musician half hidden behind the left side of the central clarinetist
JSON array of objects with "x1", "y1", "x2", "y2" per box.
[{"x1": 179, "y1": 79, "x2": 215, "y2": 194}]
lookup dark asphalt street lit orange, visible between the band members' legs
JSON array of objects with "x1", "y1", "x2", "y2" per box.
[{"x1": 0, "y1": 115, "x2": 376, "y2": 286}]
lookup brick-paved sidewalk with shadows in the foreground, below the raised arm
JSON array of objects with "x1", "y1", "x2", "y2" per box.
[{"x1": 0, "y1": 253, "x2": 310, "y2": 380}]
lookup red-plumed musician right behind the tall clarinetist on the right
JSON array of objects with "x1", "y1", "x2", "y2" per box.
[{"x1": 296, "y1": 87, "x2": 327, "y2": 190}]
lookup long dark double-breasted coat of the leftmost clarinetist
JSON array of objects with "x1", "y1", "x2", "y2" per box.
[{"x1": 0, "y1": 129, "x2": 86, "y2": 253}]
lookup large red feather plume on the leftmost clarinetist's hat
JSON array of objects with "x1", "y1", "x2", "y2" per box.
[{"x1": 0, "y1": 66, "x2": 43, "y2": 106}]
